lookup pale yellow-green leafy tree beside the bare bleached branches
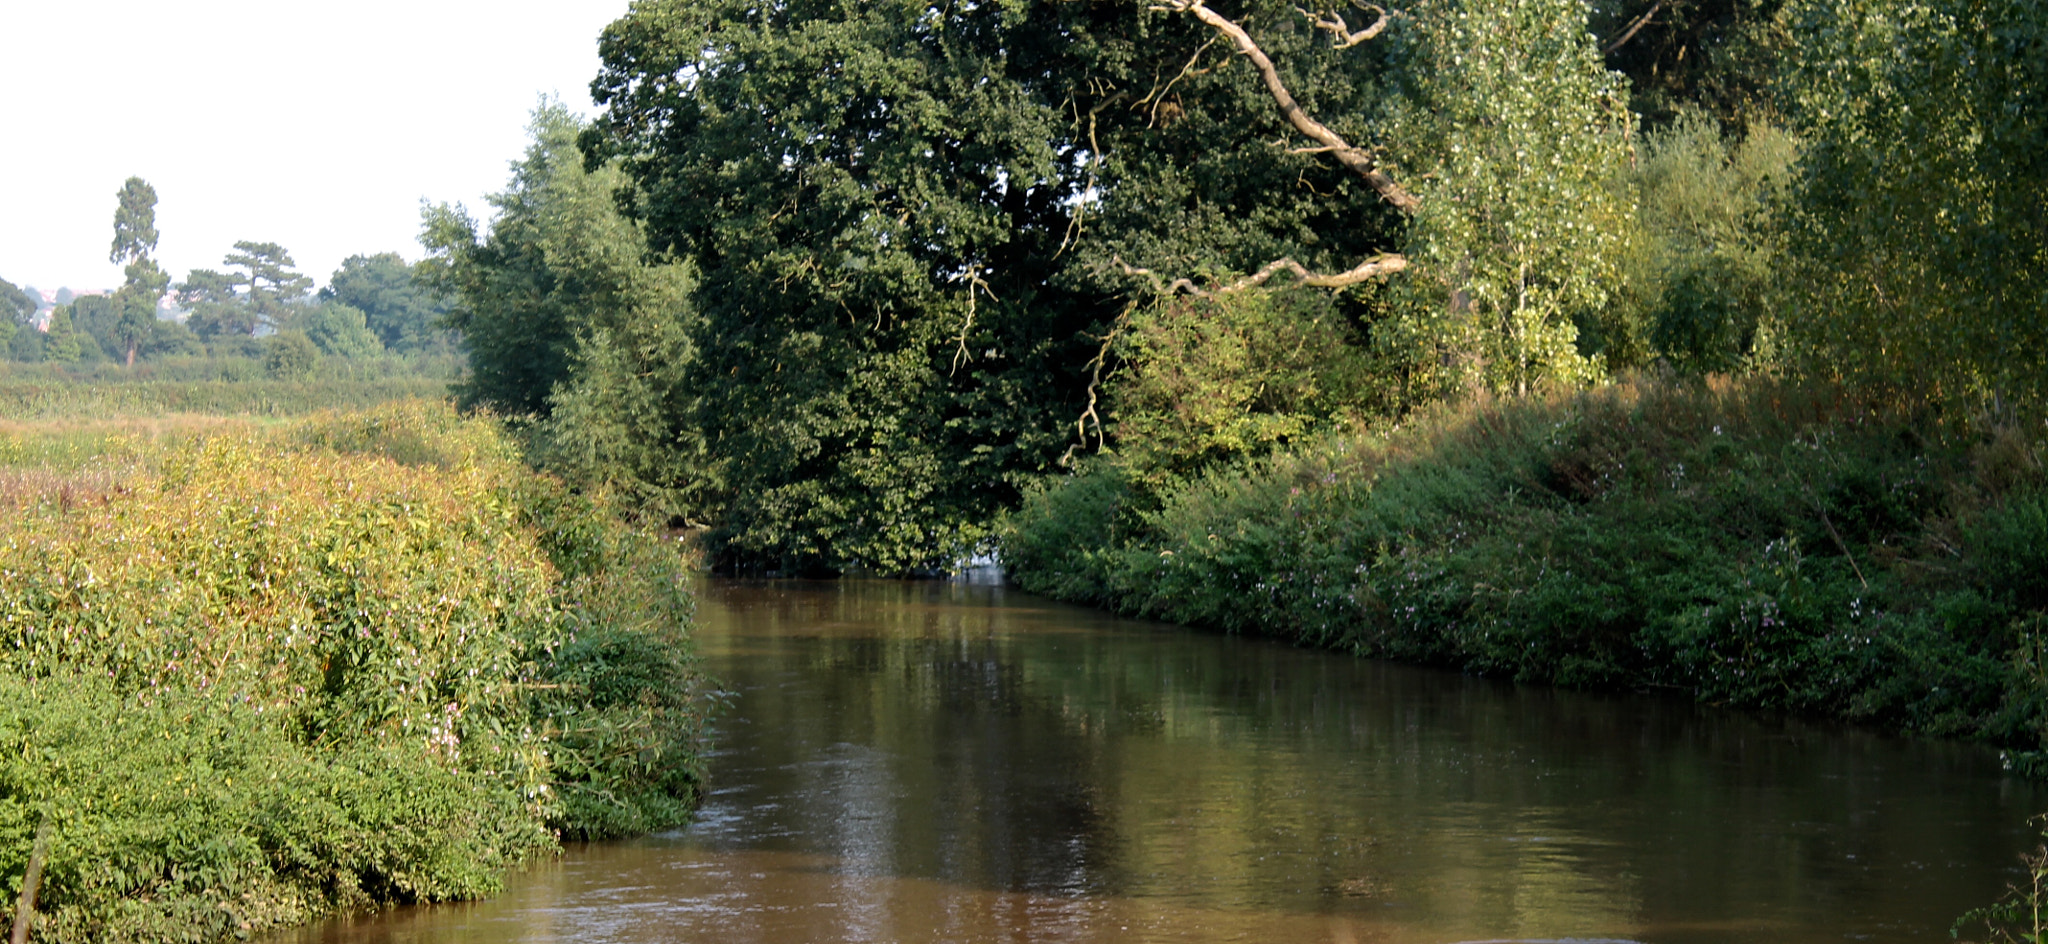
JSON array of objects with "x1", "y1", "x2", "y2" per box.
[{"x1": 1382, "y1": 0, "x2": 1634, "y2": 399}]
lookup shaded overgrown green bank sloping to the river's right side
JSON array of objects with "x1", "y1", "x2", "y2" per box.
[{"x1": 1004, "y1": 381, "x2": 2048, "y2": 766}]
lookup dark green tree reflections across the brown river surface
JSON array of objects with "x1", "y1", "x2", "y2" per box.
[{"x1": 705, "y1": 582, "x2": 2038, "y2": 934}]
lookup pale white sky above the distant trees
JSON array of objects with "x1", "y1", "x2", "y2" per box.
[{"x1": 0, "y1": 0, "x2": 627, "y2": 291}]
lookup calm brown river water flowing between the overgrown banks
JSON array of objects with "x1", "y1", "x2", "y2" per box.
[{"x1": 281, "y1": 580, "x2": 2048, "y2": 944}]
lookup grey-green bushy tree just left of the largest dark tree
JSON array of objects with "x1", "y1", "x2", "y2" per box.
[{"x1": 419, "y1": 102, "x2": 715, "y2": 520}]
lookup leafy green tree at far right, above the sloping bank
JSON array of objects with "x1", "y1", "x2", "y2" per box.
[{"x1": 1786, "y1": 0, "x2": 2048, "y2": 412}]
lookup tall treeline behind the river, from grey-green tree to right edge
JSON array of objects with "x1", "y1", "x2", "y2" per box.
[{"x1": 426, "y1": 0, "x2": 2048, "y2": 573}]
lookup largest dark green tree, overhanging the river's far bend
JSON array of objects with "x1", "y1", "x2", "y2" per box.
[{"x1": 590, "y1": 2, "x2": 1441, "y2": 571}]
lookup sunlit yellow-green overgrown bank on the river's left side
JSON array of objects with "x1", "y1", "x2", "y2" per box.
[{"x1": 0, "y1": 401, "x2": 700, "y2": 942}]
